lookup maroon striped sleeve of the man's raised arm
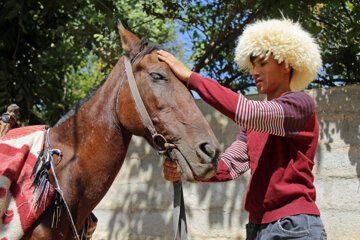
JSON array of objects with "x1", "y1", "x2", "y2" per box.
[{"x1": 188, "y1": 73, "x2": 315, "y2": 136}]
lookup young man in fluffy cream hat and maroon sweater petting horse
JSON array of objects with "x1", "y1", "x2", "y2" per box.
[{"x1": 158, "y1": 19, "x2": 326, "y2": 240}]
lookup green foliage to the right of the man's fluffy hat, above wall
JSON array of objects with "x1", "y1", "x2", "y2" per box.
[{"x1": 306, "y1": 1, "x2": 360, "y2": 87}]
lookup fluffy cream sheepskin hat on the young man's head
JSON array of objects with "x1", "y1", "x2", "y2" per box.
[{"x1": 235, "y1": 19, "x2": 322, "y2": 91}]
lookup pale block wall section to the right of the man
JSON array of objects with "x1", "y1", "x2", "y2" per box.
[{"x1": 309, "y1": 86, "x2": 360, "y2": 240}]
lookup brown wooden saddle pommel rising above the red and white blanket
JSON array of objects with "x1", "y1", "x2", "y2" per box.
[{"x1": 0, "y1": 104, "x2": 20, "y2": 140}]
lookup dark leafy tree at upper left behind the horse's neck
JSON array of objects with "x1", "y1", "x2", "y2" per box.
[{"x1": 0, "y1": 0, "x2": 175, "y2": 124}]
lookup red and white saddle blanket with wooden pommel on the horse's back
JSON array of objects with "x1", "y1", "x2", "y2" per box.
[{"x1": 0, "y1": 104, "x2": 97, "y2": 240}]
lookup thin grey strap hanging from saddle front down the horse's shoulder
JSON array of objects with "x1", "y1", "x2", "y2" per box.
[{"x1": 46, "y1": 128, "x2": 80, "y2": 240}]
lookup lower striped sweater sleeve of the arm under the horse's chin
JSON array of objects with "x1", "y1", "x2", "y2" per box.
[{"x1": 208, "y1": 129, "x2": 250, "y2": 182}]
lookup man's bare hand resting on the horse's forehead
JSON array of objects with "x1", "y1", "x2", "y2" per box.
[{"x1": 157, "y1": 50, "x2": 193, "y2": 83}]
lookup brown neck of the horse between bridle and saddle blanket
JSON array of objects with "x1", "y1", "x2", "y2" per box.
[{"x1": 50, "y1": 61, "x2": 132, "y2": 218}]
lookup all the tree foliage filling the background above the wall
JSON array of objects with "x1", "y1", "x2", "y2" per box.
[{"x1": 0, "y1": 0, "x2": 360, "y2": 124}]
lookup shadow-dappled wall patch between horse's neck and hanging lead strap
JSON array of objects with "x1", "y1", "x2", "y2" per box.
[{"x1": 107, "y1": 146, "x2": 173, "y2": 239}]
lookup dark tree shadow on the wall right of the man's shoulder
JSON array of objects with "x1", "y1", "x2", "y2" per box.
[{"x1": 309, "y1": 86, "x2": 360, "y2": 179}]
